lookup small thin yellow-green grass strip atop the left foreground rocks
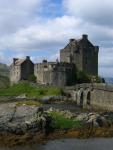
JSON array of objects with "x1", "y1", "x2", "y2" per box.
[{"x1": 16, "y1": 100, "x2": 42, "y2": 106}]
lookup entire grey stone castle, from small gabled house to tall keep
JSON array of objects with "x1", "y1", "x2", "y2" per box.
[{"x1": 10, "y1": 35, "x2": 99, "y2": 86}]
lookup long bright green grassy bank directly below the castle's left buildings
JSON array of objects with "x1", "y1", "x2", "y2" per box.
[{"x1": 0, "y1": 82, "x2": 62, "y2": 98}]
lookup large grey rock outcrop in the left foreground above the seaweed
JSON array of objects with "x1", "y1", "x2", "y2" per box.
[{"x1": 0, "y1": 103, "x2": 52, "y2": 134}]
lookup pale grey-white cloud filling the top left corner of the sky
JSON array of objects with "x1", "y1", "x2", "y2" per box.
[{"x1": 0, "y1": 0, "x2": 44, "y2": 36}]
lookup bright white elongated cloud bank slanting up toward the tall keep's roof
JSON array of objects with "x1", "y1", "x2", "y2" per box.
[{"x1": 0, "y1": 16, "x2": 81, "y2": 51}]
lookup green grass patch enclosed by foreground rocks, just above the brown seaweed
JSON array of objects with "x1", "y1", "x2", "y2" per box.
[{"x1": 50, "y1": 112, "x2": 83, "y2": 129}]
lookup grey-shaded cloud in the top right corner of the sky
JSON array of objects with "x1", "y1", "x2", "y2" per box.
[{"x1": 63, "y1": 0, "x2": 113, "y2": 26}]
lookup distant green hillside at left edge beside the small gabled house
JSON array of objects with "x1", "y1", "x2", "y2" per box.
[{"x1": 0, "y1": 63, "x2": 9, "y2": 88}]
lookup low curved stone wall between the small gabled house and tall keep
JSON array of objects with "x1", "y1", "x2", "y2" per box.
[{"x1": 34, "y1": 62, "x2": 75, "y2": 86}]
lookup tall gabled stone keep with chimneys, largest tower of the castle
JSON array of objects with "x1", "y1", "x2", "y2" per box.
[{"x1": 60, "y1": 35, "x2": 99, "y2": 75}]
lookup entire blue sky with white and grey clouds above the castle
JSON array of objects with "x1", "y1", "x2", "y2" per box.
[{"x1": 0, "y1": 0, "x2": 113, "y2": 77}]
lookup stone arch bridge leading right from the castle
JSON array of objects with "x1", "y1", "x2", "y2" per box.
[{"x1": 66, "y1": 83, "x2": 113, "y2": 110}]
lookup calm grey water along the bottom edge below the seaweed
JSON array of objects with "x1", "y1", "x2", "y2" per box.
[{"x1": 0, "y1": 138, "x2": 113, "y2": 150}]
